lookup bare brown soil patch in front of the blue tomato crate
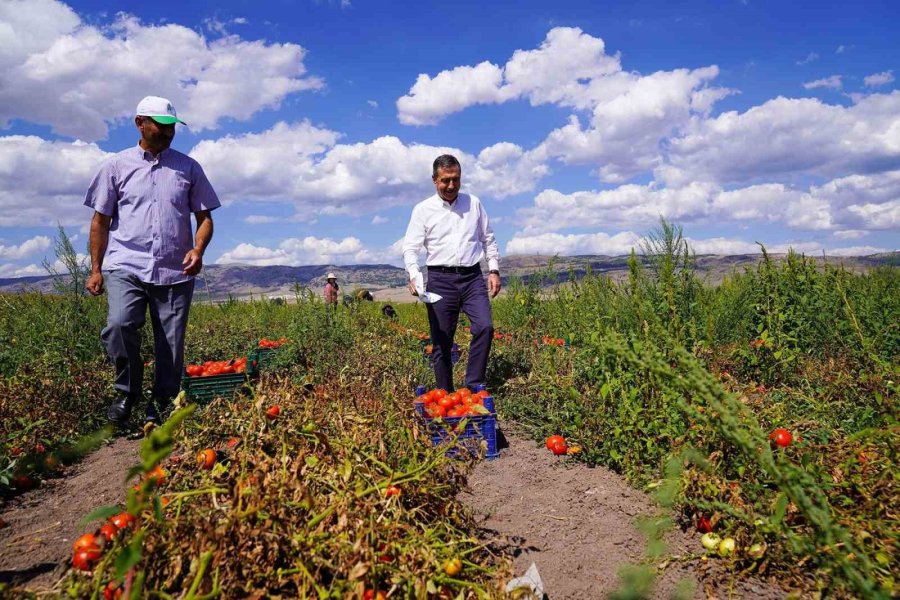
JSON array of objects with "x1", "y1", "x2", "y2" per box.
[{"x1": 461, "y1": 423, "x2": 787, "y2": 600}]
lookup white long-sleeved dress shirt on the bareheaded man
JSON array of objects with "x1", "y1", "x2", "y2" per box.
[{"x1": 403, "y1": 193, "x2": 500, "y2": 279}]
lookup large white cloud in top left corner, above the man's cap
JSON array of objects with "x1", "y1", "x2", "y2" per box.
[{"x1": 0, "y1": 0, "x2": 323, "y2": 140}]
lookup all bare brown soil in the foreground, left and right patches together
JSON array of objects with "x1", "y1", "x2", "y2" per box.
[{"x1": 0, "y1": 424, "x2": 786, "y2": 600}]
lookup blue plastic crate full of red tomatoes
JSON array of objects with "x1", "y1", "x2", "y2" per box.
[{"x1": 415, "y1": 387, "x2": 500, "y2": 459}]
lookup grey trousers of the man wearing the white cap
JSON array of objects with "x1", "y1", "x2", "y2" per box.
[{"x1": 100, "y1": 269, "x2": 194, "y2": 402}]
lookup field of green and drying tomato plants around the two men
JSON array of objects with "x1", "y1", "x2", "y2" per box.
[{"x1": 0, "y1": 237, "x2": 900, "y2": 598}]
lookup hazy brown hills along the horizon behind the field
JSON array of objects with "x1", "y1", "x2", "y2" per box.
[{"x1": 0, "y1": 252, "x2": 900, "y2": 302}]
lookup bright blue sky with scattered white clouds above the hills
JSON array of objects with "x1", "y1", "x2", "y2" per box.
[{"x1": 0, "y1": 0, "x2": 900, "y2": 277}]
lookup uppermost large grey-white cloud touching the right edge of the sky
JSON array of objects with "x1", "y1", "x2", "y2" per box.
[{"x1": 655, "y1": 91, "x2": 900, "y2": 187}]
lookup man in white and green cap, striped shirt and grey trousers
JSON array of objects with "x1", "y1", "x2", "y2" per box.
[{"x1": 84, "y1": 96, "x2": 221, "y2": 426}]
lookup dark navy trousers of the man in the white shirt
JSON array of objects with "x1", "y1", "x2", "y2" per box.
[{"x1": 425, "y1": 265, "x2": 494, "y2": 392}]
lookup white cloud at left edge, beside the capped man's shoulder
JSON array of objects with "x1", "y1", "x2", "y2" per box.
[{"x1": 0, "y1": 135, "x2": 109, "y2": 227}]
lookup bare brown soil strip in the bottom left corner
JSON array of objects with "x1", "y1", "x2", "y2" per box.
[{"x1": 0, "y1": 438, "x2": 140, "y2": 593}]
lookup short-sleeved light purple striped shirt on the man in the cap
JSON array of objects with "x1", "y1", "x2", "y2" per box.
[{"x1": 84, "y1": 146, "x2": 221, "y2": 285}]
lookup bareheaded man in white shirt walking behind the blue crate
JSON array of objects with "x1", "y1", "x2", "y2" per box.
[{"x1": 403, "y1": 154, "x2": 500, "y2": 392}]
